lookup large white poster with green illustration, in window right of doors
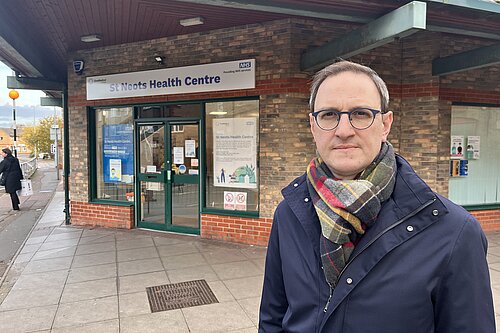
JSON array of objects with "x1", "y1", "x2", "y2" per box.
[{"x1": 213, "y1": 118, "x2": 257, "y2": 188}]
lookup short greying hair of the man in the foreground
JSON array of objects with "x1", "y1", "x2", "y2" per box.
[{"x1": 309, "y1": 60, "x2": 389, "y2": 113}]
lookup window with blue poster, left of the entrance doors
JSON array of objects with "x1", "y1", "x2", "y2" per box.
[{"x1": 93, "y1": 107, "x2": 134, "y2": 201}]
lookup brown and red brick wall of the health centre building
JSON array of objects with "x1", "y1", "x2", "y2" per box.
[{"x1": 68, "y1": 19, "x2": 500, "y2": 244}]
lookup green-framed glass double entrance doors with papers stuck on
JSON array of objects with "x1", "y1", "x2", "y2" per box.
[{"x1": 135, "y1": 118, "x2": 200, "y2": 234}]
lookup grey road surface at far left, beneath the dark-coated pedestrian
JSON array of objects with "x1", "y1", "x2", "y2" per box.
[{"x1": 0, "y1": 160, "x2": 59, "y2": 277}]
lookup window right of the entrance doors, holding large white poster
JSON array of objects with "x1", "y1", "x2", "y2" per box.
[{"x1": 205, "y1": 100, "x2": 259, "y2": 212}]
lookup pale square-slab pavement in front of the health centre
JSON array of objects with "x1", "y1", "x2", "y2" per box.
[{"x1": 0, "y1": 176, "x2": 500, "y2": 333}]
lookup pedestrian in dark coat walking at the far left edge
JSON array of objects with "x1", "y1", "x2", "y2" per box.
[{"x1": 0, "y1": 148, "x2": 23, "y2": 210}]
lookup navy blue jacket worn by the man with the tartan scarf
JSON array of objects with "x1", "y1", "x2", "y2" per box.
[{"x1": 259, "y1": 156, "x2": 495, "y2": 333}]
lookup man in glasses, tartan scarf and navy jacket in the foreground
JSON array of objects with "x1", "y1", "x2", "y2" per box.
[{"x1": 259, "y1": 61, "x2": 495, "y2": 333}]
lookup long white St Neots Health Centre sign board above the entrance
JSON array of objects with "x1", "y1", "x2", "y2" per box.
[{"x1": 87, "y1": 59, "x2": 255, "y2": 101}]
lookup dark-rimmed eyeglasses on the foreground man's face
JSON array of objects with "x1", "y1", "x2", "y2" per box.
[{"x1": 311, "y1": 108, "x2": 383, "y2": 131}]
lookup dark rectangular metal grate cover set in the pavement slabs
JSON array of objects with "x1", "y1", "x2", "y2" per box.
[{"x1": 146, "y1": 280, "x2": 219, "y2": 312}]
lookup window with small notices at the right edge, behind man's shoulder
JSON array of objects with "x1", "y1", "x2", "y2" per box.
[{"x1": 449, "y1": 105, "x2": 500, "y2": 205}]
